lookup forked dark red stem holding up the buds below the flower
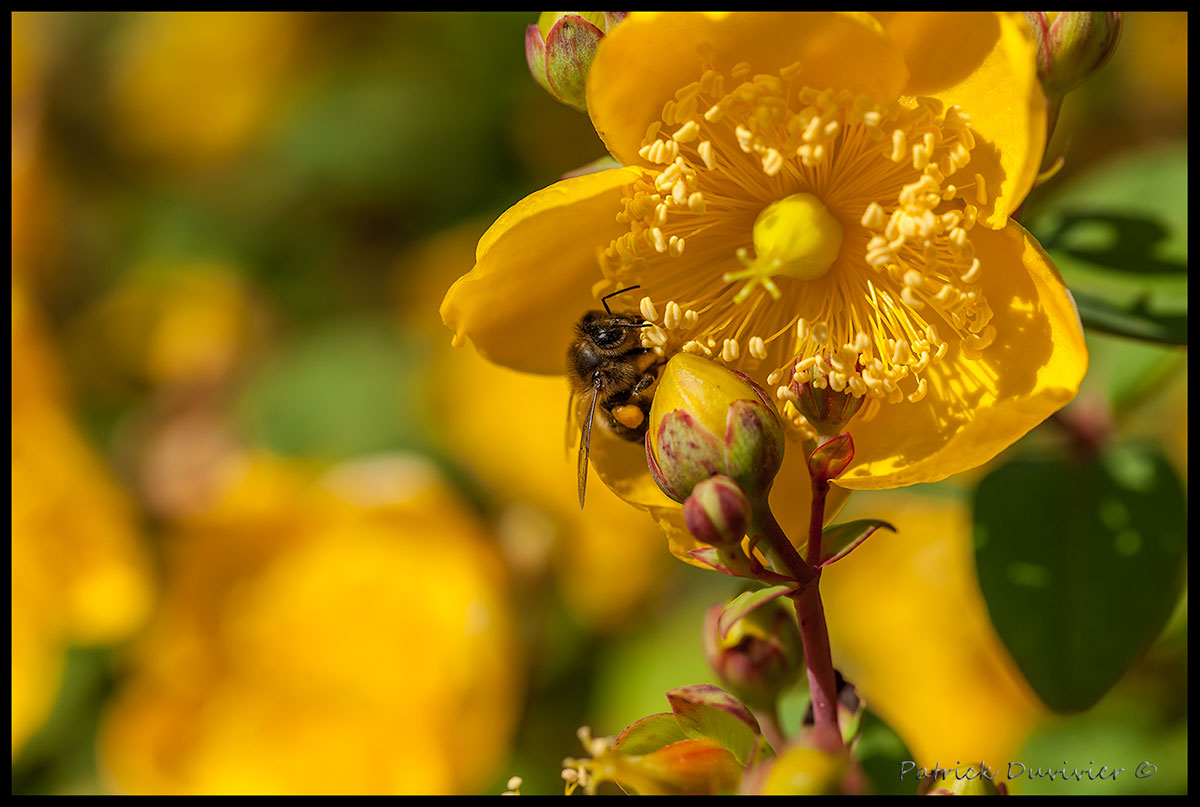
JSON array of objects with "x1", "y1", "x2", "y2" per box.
[{"x1": 754, "y1": 504, "x2": 841, "y2": 743}]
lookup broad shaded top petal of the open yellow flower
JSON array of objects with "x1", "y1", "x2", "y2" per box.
[{"x1": 588, "y1": 12, "x2": 907, "y2": 166}]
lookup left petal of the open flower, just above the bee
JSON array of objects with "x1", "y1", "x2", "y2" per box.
[{"x1": 442, "y1": 168, "x2": 637, "y2": 373}]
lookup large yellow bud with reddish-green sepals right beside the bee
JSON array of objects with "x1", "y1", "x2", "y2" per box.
[{"x1": 646, "y1": 353, "x2": 784, "y2": 502}]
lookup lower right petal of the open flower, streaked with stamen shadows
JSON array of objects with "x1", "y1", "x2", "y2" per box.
[{"x1": 838, "y1": 222, "x2": 1087, "y2": 490}]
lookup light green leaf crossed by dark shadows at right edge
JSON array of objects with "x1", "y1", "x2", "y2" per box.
[{"x1": 1026, "y1": 144, "x2": 1188, "y2": 345}]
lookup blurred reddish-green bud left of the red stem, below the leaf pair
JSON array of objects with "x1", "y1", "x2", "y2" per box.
[{"x1": 703, "y1": 599, "x2": 804, "y2": 707}]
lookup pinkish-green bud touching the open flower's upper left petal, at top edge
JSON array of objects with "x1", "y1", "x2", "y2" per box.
[{"x1": 526, "y1": 11, "x2": 626, "y2": 112}]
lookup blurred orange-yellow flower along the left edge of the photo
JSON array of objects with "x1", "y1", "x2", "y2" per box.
[{"x1": 12, "y1": 283, "x2": 151, "y2": 758}]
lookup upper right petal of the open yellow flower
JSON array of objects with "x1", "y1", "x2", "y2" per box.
[{"x1": 876, "y1": 11, "x2": 1046, "y2": 229}]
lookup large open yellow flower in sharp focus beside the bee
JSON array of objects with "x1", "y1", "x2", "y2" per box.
[{"x1": 442, "y1": 12, "x2": 1087, "y2": 504}]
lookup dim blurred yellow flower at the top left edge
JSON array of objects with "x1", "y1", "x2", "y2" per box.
[{"x1": 109, "y1": 12, "x2": 306, "y2": 168}]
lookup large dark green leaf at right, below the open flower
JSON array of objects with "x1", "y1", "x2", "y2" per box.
[{"x1": 974, "y1": 446, "x2": 1187, "y2": 711}]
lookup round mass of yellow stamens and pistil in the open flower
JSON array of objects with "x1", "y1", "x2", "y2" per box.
[{"x1": 600, "y1": 62, "x2": 996, "y2": 417}]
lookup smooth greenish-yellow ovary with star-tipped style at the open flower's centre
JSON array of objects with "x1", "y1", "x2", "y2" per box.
[{"x1": 724, "y1": 193, "x2": 842, "y2": 303}]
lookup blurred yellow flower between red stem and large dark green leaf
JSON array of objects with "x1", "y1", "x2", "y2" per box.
[{"x1": 821, "y1": 494, "x2": 1048, "y2": 767}]
